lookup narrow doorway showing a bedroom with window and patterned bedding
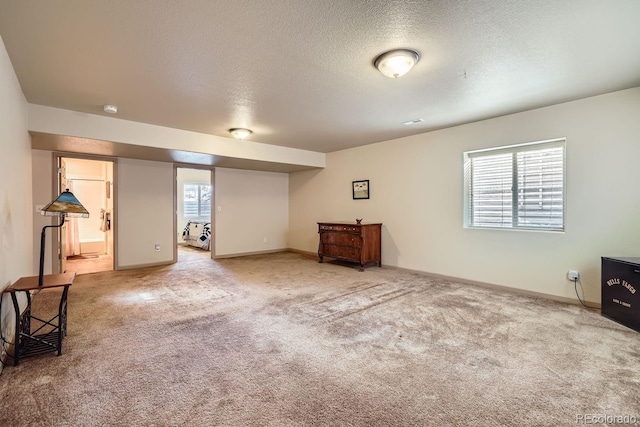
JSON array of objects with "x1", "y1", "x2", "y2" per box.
[{"x1": 175, "y1": 166, "x2": 215, "y2": 262}]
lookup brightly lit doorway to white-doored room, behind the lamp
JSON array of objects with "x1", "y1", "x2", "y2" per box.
[{"x1": 58, "y1": 157, "x2": 115, "y2": 274}]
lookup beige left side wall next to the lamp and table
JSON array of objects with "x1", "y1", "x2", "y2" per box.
[{"x1": 0, "y1": 38, "x2": 31, "y2": 372}]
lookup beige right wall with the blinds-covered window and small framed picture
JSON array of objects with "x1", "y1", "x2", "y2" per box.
[{"x1": 289, "y1": 88, "x2": 640, "y2": 302}]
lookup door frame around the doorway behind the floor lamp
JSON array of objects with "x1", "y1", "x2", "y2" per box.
[{"x1": 51, "y1": 151, "x2": 119, "y2": 274}]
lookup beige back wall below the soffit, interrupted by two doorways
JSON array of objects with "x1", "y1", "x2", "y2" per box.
[{"x1": 30, "y1": 154, "x2": 289, "y2": 273}]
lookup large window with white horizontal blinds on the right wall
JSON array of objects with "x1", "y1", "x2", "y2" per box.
[{"x1": 464, "y1": 139, "x2": 565, "y2": 231}]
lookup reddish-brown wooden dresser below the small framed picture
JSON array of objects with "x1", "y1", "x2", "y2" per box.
[{"x1": 318, "y1": 222, "x2": 382, "y2": 271}]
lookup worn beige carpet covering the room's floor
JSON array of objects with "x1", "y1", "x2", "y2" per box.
[{"x1": 0, "y1": 248, "x2": 640, "y2": 426}]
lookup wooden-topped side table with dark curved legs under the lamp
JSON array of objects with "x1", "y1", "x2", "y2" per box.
[{"x1": 4, "y1": 273, "x2": 76, "y2": 366}]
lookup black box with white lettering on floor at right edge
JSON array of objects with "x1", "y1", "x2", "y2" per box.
[{"x1": 602, "y1": 257, "x2": 640, "y2": 332}]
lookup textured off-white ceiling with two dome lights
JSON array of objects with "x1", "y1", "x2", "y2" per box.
[{"x1": 0, "y1": 0, "x2": 640, "y2": 152}]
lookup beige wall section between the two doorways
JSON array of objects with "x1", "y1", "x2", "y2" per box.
[{"x1": 114, "y1": 159, "x2": 175, "y2": 268}]
